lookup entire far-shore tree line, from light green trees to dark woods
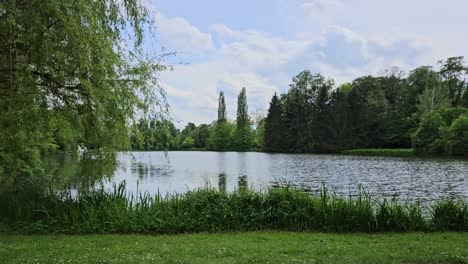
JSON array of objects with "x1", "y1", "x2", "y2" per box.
[{"x1": 132, "y1": 57, "x2": 468, "y2": 155}]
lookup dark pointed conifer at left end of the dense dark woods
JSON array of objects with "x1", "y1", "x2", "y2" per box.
[{"x1": 264, "y1": 93, "x2": 284, "y2": 152}]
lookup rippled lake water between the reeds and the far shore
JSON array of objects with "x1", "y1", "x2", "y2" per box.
[{"x1": 45, "y1": 152, "x2": 468, "y2": 201}]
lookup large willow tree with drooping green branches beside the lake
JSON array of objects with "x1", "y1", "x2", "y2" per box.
[{"x1": 0, "y1": 0, "x2": 164, "y2": 184}]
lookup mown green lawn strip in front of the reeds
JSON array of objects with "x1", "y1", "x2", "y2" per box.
[{"x1": 0, "y1": 232, "x2": 468, "y2": 263}]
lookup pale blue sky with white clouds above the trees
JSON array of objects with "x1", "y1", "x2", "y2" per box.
[{"x1": 144, "y1": 0, "x2": 468, "y2": 128}]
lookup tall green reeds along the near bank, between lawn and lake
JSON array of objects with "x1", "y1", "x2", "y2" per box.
[{"x1": 0, "y1": 184, "x2": 468, "y2": 234}]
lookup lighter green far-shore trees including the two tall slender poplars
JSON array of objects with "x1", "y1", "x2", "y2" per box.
[{"x1": 130, "y1": 88, "x2": 263, "y2": 151}]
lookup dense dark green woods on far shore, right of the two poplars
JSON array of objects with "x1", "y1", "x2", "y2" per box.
[{"x1": 265, "y1": 57, "x2": 468, "y2": 155}]
